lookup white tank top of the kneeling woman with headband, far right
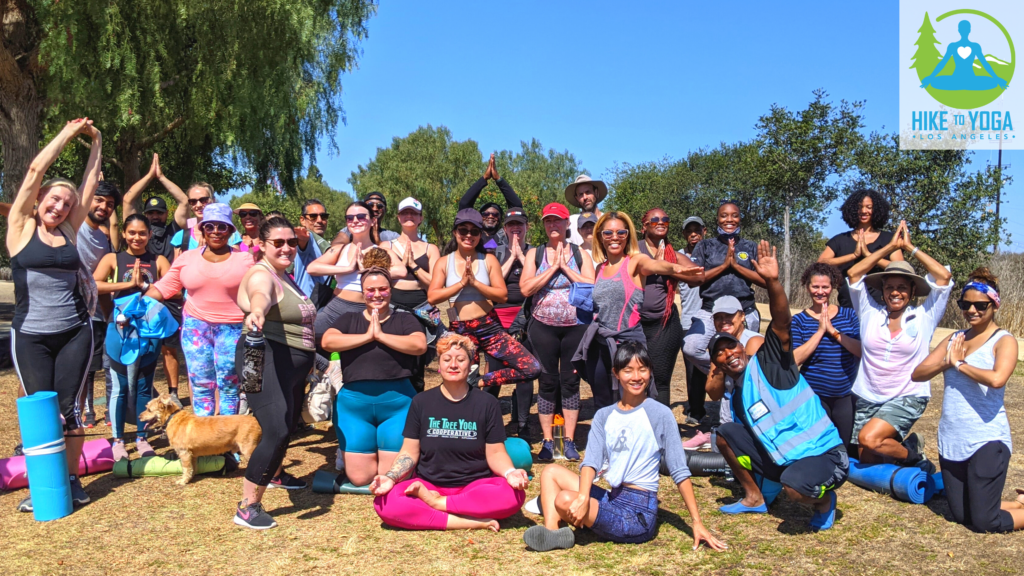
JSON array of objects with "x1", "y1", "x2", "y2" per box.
[{"x1": 939, "y1": 330, "x2": 1013, "y2": 462}]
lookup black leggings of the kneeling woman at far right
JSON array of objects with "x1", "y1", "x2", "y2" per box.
[{"x1": 939, "y1": 441, "x2": 1014, "y2": 532}]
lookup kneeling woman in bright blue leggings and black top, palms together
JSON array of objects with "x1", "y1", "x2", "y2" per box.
[{"x1": 321, "y1": 248, "x2": 427, "y2": 486}]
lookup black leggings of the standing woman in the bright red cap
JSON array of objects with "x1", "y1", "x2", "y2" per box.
[{"x1": 528, "y1": 320, "x2": 587, "y2": 414}]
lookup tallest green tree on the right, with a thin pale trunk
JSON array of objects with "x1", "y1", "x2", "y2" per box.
[{"x1": 757, "y1": 89, "x2": 863, "y2": 295}]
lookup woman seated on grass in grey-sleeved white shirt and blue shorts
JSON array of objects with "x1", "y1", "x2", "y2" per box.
[{"x1": 523, "y1": 341, "x2": 727, "y2": 551}]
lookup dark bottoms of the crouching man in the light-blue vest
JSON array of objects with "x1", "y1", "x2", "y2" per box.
[{"x1": 718, "y1": 422, "x2": 850, "y2": 498}]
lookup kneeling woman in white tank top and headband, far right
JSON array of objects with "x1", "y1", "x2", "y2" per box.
[{"x1": 913, "y1": 268, "x2": 1024, "y2": 532}]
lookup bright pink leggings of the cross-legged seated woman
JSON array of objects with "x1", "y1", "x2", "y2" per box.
[{"x1": 374, "y1": 477, "x2": 526, "y2": 530}]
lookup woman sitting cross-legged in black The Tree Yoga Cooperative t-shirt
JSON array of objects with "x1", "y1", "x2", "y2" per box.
[{"x1": 370, "y1": 333, "x2": 529, "y2": 532}]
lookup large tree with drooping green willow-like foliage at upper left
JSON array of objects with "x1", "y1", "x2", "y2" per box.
[{"x1": 0, "y1": 0, "x2": 376, "y2": 198}]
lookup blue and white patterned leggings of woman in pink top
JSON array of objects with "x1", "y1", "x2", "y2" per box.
[{"x1": 181, "y1": 315, "x2": 242, "y2": 416}]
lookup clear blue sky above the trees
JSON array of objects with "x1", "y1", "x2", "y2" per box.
[{"x1": 307, "y1": 0, "x2": 1024, "y2": 251}]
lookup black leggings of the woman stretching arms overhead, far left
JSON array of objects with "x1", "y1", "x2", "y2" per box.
[{"x1": 10, "y1": 322, "x2": 92, "y2": 431}]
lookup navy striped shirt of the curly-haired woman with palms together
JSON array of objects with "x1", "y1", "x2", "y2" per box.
[{"x1": 792, "y1": 307, "x2": 860, "y2": 398}]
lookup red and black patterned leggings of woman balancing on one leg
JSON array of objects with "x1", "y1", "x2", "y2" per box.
[{"x1": 452, "y1": 310, "x2": 541, "y2": 386}]
